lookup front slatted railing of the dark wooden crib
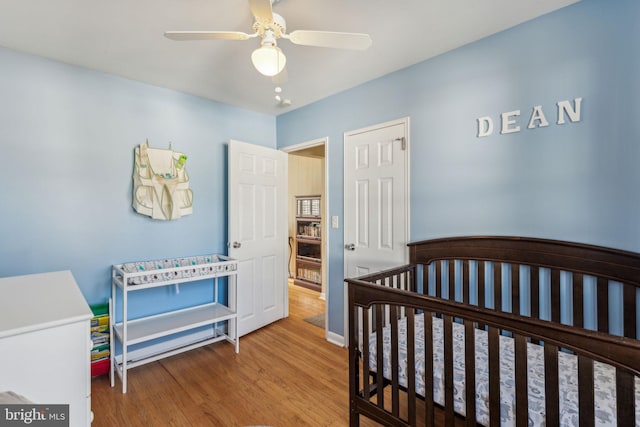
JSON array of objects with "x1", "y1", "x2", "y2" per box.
[{"x1": 347, "y1": 259, "x2": 640, "y2": 426}]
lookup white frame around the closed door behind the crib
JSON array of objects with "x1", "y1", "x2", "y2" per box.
[{"x1": 342, "y1": 116, "x2": 411, "y2": 347}]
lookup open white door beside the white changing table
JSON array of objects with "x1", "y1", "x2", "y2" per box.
[{"x1": 228, "y1": 140, "x2": 288, "y2": 336}]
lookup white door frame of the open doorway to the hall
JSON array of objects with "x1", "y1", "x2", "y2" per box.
[{"x1": 281, "y1": 136, "x2": 331, "y2": 339}]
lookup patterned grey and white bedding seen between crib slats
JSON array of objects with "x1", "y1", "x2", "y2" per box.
[{"x1": 369, "y1": 314, "x2": 640, "y2": 426}]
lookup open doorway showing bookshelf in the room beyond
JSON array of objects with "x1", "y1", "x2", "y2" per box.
[{"x1": 284, "y1": 138, "x2": 328, "y2": 335}]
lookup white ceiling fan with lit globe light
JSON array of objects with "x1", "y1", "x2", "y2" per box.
[{"x1": 164, "y1": 0, "x2": 371, "y2": 76}]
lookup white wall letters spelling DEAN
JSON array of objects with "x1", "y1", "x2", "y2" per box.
[{"x1": 478, "y1": 98, "x2": 582, "y2": 138}]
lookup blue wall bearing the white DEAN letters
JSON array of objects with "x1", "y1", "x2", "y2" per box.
[{"x1": 277, "y1": 0, "x2": 640, "y2": 335}]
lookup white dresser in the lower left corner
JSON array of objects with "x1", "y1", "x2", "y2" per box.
[{"x1": 0, "y1": 271, "x2": 92, "y2": 427}]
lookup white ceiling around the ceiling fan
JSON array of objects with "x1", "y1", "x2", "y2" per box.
[{"x1": 0, "y1": 0, "x2": 579, "y2": 115}]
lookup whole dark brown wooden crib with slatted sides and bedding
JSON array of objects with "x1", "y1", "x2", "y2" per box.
[{"x1": 346, "y1": 236, "x2": 640, "y2": 426}]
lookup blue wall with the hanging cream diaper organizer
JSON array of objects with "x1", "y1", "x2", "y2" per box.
[{"x1": 0, "y1": 48, "x2": 276, "y2": 314}]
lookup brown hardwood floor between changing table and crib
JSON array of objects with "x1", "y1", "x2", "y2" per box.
[{"x1": 91, "y1": 285, "x2": 384, "y2": 427}]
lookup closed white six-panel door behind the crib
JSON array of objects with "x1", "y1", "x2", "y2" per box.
[{"x1": 344, "y1": 119, "x2": 409, "y2": 277}]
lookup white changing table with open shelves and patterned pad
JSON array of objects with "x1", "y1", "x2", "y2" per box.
[{"x1": 110, "y1": 255, "x2": 240, "y2": 393}]
